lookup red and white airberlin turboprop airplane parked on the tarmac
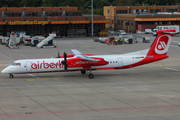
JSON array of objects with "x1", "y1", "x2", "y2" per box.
[{"x1": 1, "y1": 30, "x2": 175, "y2": 79}]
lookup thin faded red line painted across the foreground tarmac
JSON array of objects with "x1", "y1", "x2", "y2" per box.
[{"x1": 0, "y1": 106, "x2": 180, "y2": 117}]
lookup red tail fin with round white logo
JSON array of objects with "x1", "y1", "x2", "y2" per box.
[{"x1": 147, "y1": 30, "x2": 175, "y2": 56}]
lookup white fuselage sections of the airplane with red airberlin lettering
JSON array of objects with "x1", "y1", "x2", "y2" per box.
[{"x1": 2, "y1": 50, "x2": 148, "y2": 74}]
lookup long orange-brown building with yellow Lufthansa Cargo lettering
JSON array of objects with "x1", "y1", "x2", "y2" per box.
[{"x1": 0, "y1": 7, "x2": 110, "y2": 37}]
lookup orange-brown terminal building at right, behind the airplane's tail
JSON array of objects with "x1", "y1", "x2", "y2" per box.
[{"x1": 104, "y1": 5, "x2": 180, "y2": 33}]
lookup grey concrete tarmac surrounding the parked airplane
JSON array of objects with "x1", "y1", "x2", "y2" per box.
[{"x1": 0, "y1": 34, "x2": 180, "y2": 120}]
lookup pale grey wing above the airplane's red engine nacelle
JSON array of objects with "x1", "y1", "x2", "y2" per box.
[{"x1": 71, "y1": 49, "x2": 99, "y2": 61}]
